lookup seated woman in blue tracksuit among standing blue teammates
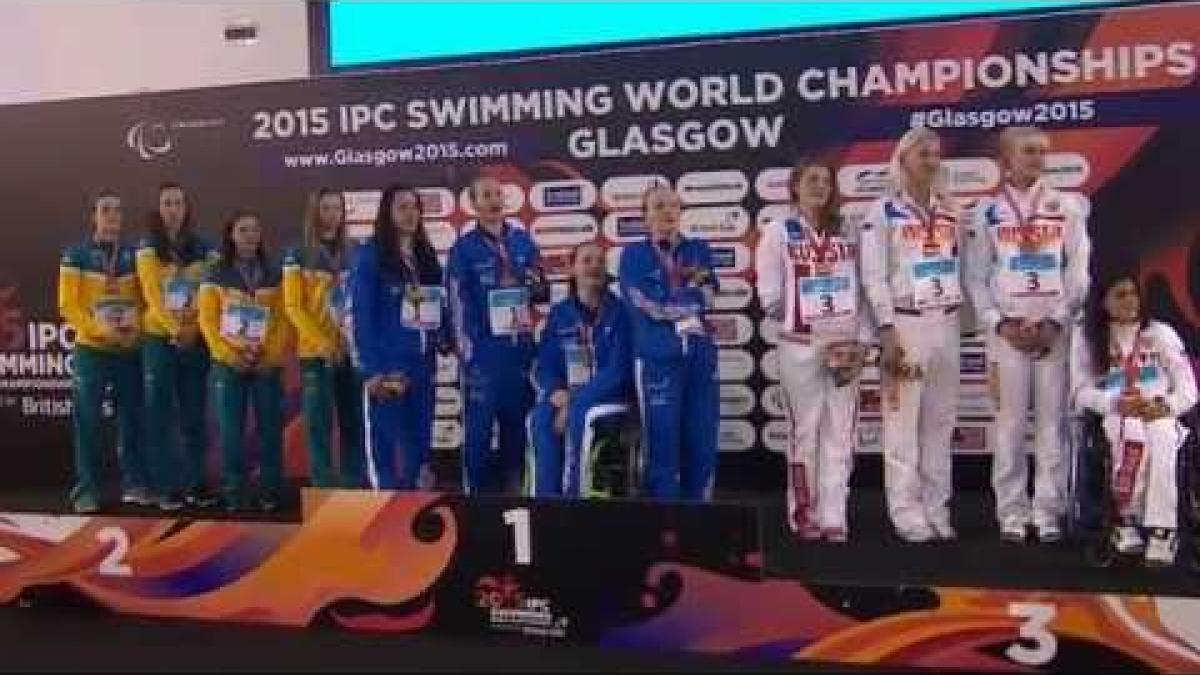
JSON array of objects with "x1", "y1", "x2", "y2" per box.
[{"x1": 529, "y1": 243, "x2": 631, "y2": 497}]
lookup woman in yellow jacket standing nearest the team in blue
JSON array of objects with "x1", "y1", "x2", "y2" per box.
[{"x1": 283, "y1": 189, "x2": 364, "y2": 488}]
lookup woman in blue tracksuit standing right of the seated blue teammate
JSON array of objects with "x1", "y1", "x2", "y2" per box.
[{"x1": 620, "y1": 185, "x2": 720, "y2": 501}]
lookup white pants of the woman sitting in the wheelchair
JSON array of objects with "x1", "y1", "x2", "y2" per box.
[{"x1": 1104, "y1": 414, "x2": 1187, "y2": 530}]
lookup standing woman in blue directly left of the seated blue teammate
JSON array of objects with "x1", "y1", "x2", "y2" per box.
[{"x1": 446, "y1": 177, "x2": 550, "y2": 494}]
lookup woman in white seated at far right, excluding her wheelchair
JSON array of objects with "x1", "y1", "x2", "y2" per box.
[{"x1": 1070, "y1": 273, "x2": 1196, "y2": 567}]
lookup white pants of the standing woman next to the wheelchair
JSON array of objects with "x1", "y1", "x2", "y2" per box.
[{"x1": 988, "y1": 331, "x2": 1070, "y2": 525}]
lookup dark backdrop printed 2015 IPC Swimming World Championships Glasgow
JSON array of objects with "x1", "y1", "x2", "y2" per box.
[{"x1": 0, "y1": 4, "x2": 1200, "y2": 488}]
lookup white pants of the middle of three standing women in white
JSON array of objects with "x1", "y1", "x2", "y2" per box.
[{"x1": 882, "y1": 310, "x2": 959, "y2": 530}]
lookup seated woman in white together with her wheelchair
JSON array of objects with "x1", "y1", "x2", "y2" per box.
[{"x1": 1070, "y1": 273, "x2": 1200, "y2": 567}]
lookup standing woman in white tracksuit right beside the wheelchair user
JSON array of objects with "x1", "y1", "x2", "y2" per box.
[{"x1": 965, "y1": 126, "x2": 1090, "y2": 543}]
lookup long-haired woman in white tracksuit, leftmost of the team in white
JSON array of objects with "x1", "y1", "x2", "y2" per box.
[{"x1": 755, "y1": 160, "x2": 872, "y2": 542}]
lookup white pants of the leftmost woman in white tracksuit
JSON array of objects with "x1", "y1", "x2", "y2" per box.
[{"x1": 779, "y1": 340, "x2": 858, "y2": 531}]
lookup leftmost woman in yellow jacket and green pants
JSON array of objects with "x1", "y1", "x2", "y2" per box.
[{"x1": 59, "y1": 191, "x2": 151, "y2": 513}]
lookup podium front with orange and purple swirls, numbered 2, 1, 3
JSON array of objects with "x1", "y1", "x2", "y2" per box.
[{"x1": 0, "y1": 491, "x2": 1200, "y2": 673}]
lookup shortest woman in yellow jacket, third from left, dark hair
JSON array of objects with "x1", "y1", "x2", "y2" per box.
[{"x1": 199, "y1": 211, "x2": 290, "y2": 510}]
